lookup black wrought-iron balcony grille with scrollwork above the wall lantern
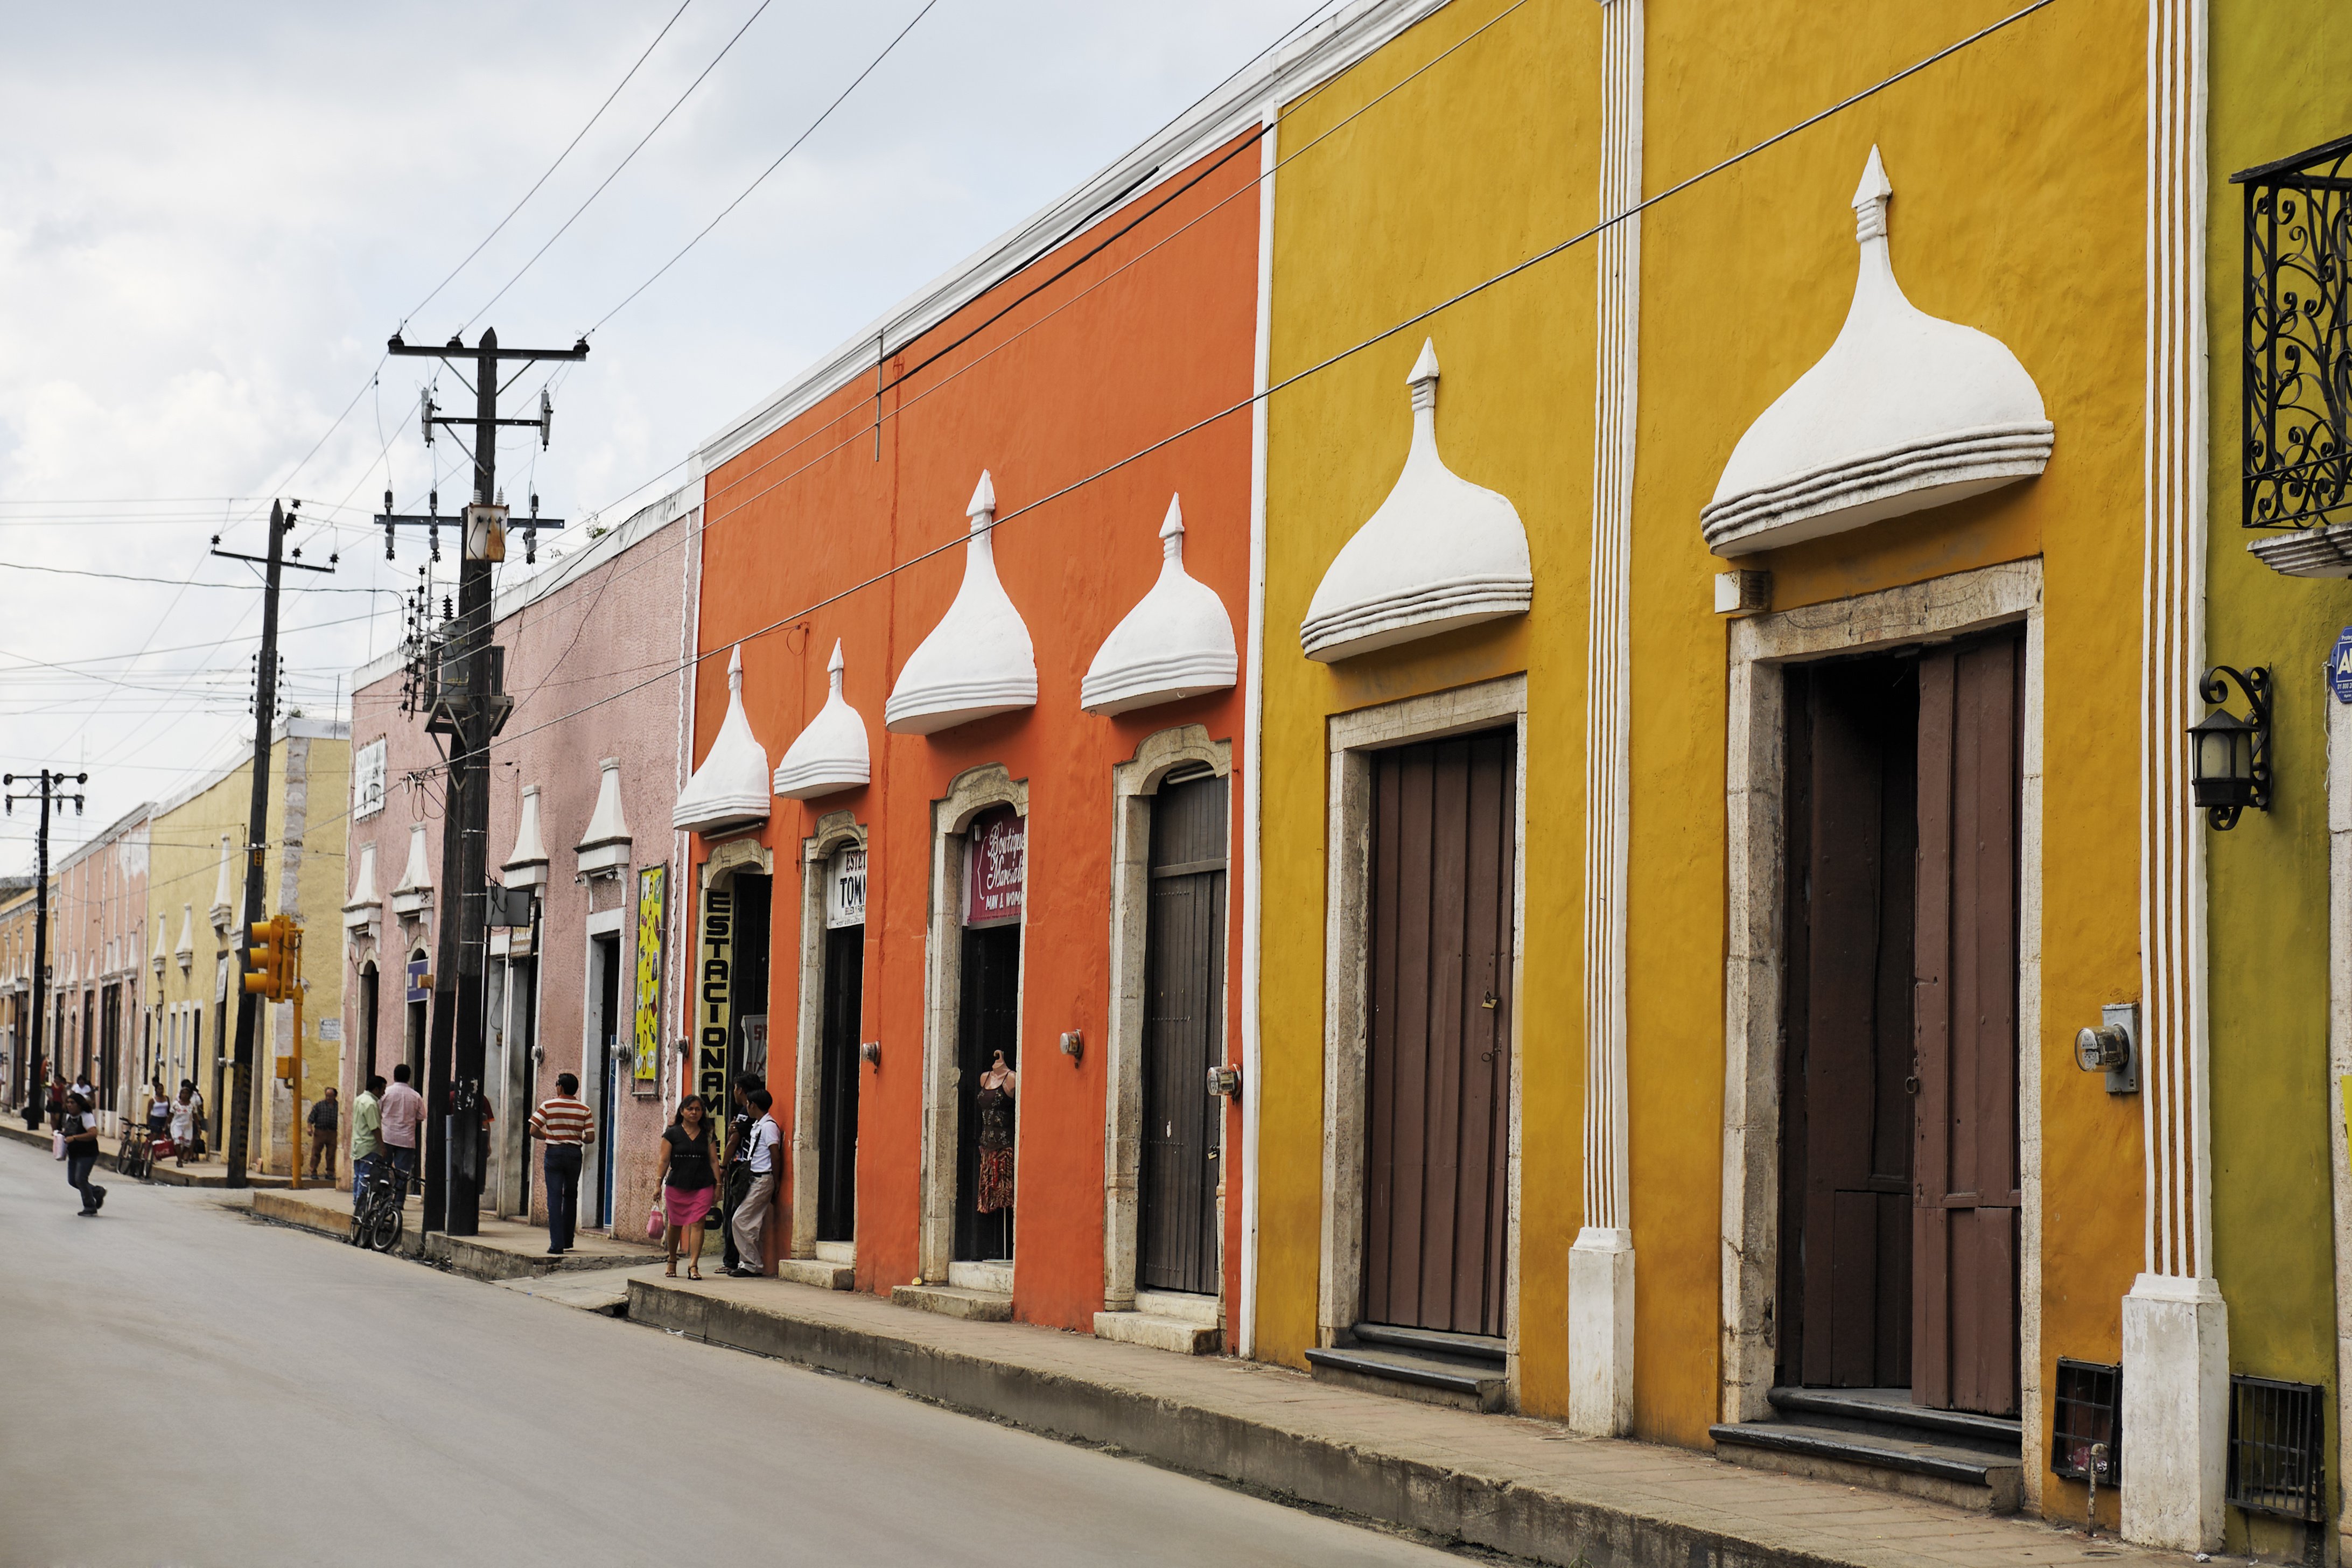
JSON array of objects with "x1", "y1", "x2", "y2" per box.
[{"x1": 2230, "y1": 136, "x2": 2352, "y2": 529}]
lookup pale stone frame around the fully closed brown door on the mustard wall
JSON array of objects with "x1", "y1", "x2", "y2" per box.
[{"x1": 1315, "y1": 675, "x2": 1527, "y2": 1406}]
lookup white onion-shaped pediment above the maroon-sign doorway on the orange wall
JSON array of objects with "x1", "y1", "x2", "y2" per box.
[{"x1": 882, "y1": 473, "x2": 1037, "y2": 736}]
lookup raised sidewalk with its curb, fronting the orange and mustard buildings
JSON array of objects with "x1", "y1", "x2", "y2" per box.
[{"x1": 628, "y1": 1272, "x2": 2190, "y2": 1568}]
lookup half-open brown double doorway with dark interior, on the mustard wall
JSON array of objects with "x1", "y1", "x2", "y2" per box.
[{"x1": 1776, "y1": 632, "x2": 2022, "y2": 1415}]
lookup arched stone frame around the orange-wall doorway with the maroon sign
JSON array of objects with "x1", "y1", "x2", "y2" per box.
[{"x1": 917, "y1": 762, "x2": 1037, "y2": 1284}]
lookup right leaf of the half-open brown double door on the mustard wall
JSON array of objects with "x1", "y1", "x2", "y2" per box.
[{"x1": 1912, "y1": 637, "x2": 2022, "y2": 1415}]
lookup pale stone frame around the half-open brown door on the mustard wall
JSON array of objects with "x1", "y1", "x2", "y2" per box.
[{"x1": 1721, "y1": 557, "x2": 2044, "y2": 1502}]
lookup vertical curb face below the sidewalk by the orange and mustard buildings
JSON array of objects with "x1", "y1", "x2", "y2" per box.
[{"x1": 628, "y1": 1279, "x2": 1853, "y2": 1568}]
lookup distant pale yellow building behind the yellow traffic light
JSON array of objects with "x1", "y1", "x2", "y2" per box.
[{"x1": 148, "y1": 717, "x2": 351, "y2": 1175}]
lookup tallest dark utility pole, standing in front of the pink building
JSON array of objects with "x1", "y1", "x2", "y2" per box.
[{"x1": 376, "y1": 329, "x2": 588, "y2": 1236}]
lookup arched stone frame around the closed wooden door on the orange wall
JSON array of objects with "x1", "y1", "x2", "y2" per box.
[{"x1": 1103, "y1": 724, "x2": 1235, "y2": 1321}]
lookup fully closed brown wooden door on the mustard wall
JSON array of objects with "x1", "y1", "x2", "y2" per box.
[{"x1": 1364, "y1": 729, "x2": 1517, "y2": 1335}]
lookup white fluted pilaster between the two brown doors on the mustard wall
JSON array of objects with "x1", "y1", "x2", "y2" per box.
[{"x1": 1569, "y1": 0, "x2": 1642, "y2": 1437}]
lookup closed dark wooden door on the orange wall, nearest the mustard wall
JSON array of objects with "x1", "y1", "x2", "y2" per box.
[{"x1": 1136, "y1": 778, "x2": 1226, "y2": 1296}]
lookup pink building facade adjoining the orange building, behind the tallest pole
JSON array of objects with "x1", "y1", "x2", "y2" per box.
[{"x1": 341, "y1": 484, "x2": 701, "y2": 1234}]
